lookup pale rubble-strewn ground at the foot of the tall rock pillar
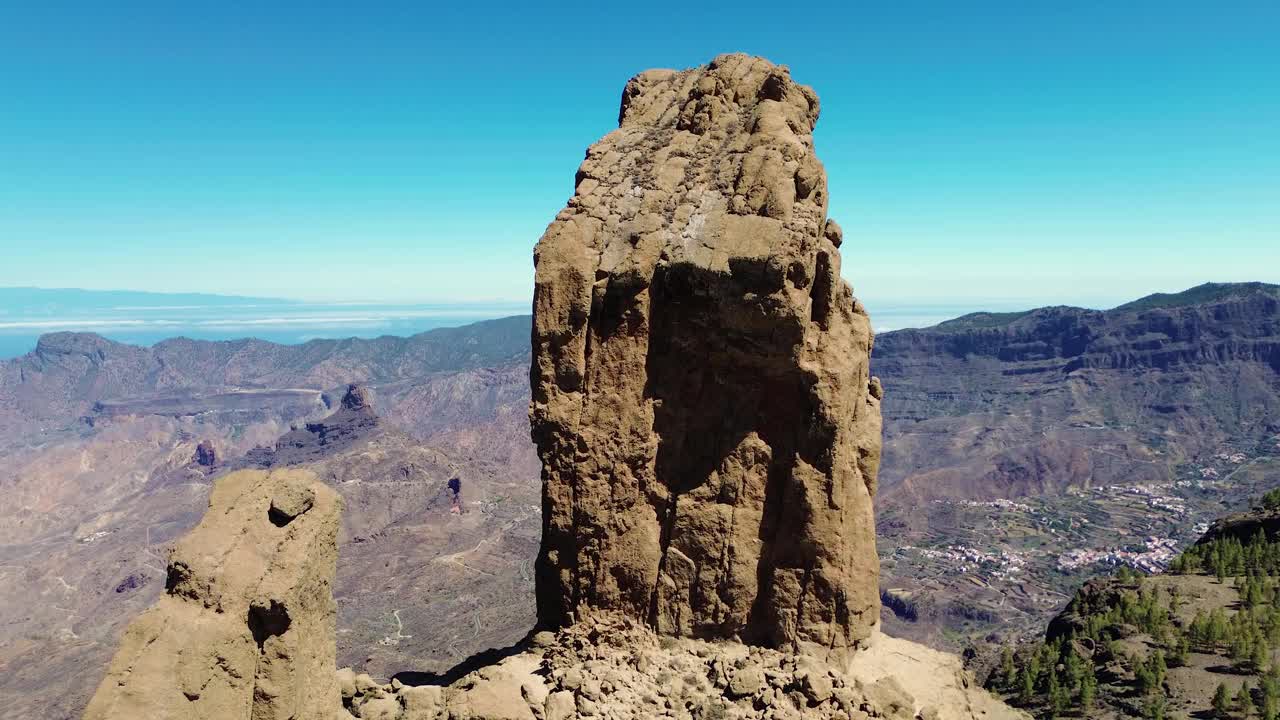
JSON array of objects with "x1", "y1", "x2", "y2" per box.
[{"x1": 339, "y1": 615, "x2": 1021, "y2": 720}]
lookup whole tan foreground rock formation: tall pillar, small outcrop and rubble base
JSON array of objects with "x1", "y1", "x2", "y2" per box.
[{"x1": 86, "y1": 55, "x2": 1019, "y2": 720}]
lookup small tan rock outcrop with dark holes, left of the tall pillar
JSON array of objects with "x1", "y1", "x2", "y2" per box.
[{"x1": 84, "y1": 470, "x2": 342, "y2": 720}]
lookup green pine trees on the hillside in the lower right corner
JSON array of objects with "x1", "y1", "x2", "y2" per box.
[{"x1": 988, "y1": 517, "x2": 1280, "y2": 720}]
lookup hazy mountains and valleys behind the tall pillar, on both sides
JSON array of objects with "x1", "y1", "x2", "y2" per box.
[{"x1": 0, "y1": 283, "x2": 1280, "y2": 716}]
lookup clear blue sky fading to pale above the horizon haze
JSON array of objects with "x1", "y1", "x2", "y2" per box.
[{"x1": 0, "y1": 0, "x2": 1280, "y2": 309}]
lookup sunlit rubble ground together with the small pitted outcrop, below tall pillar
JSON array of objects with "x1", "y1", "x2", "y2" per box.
[{"x1": 84, "y1": 470, "x2": 1015, "y2": 720}]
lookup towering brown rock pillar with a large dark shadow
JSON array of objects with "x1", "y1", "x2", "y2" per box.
[{"x1": 530, "y1": 55, "x2": 881, "y2": 655}]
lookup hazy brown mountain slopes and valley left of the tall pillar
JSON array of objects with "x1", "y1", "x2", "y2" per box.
[{"x1": 0, "y1": 333, "x2": 538, "y2": 719}]
